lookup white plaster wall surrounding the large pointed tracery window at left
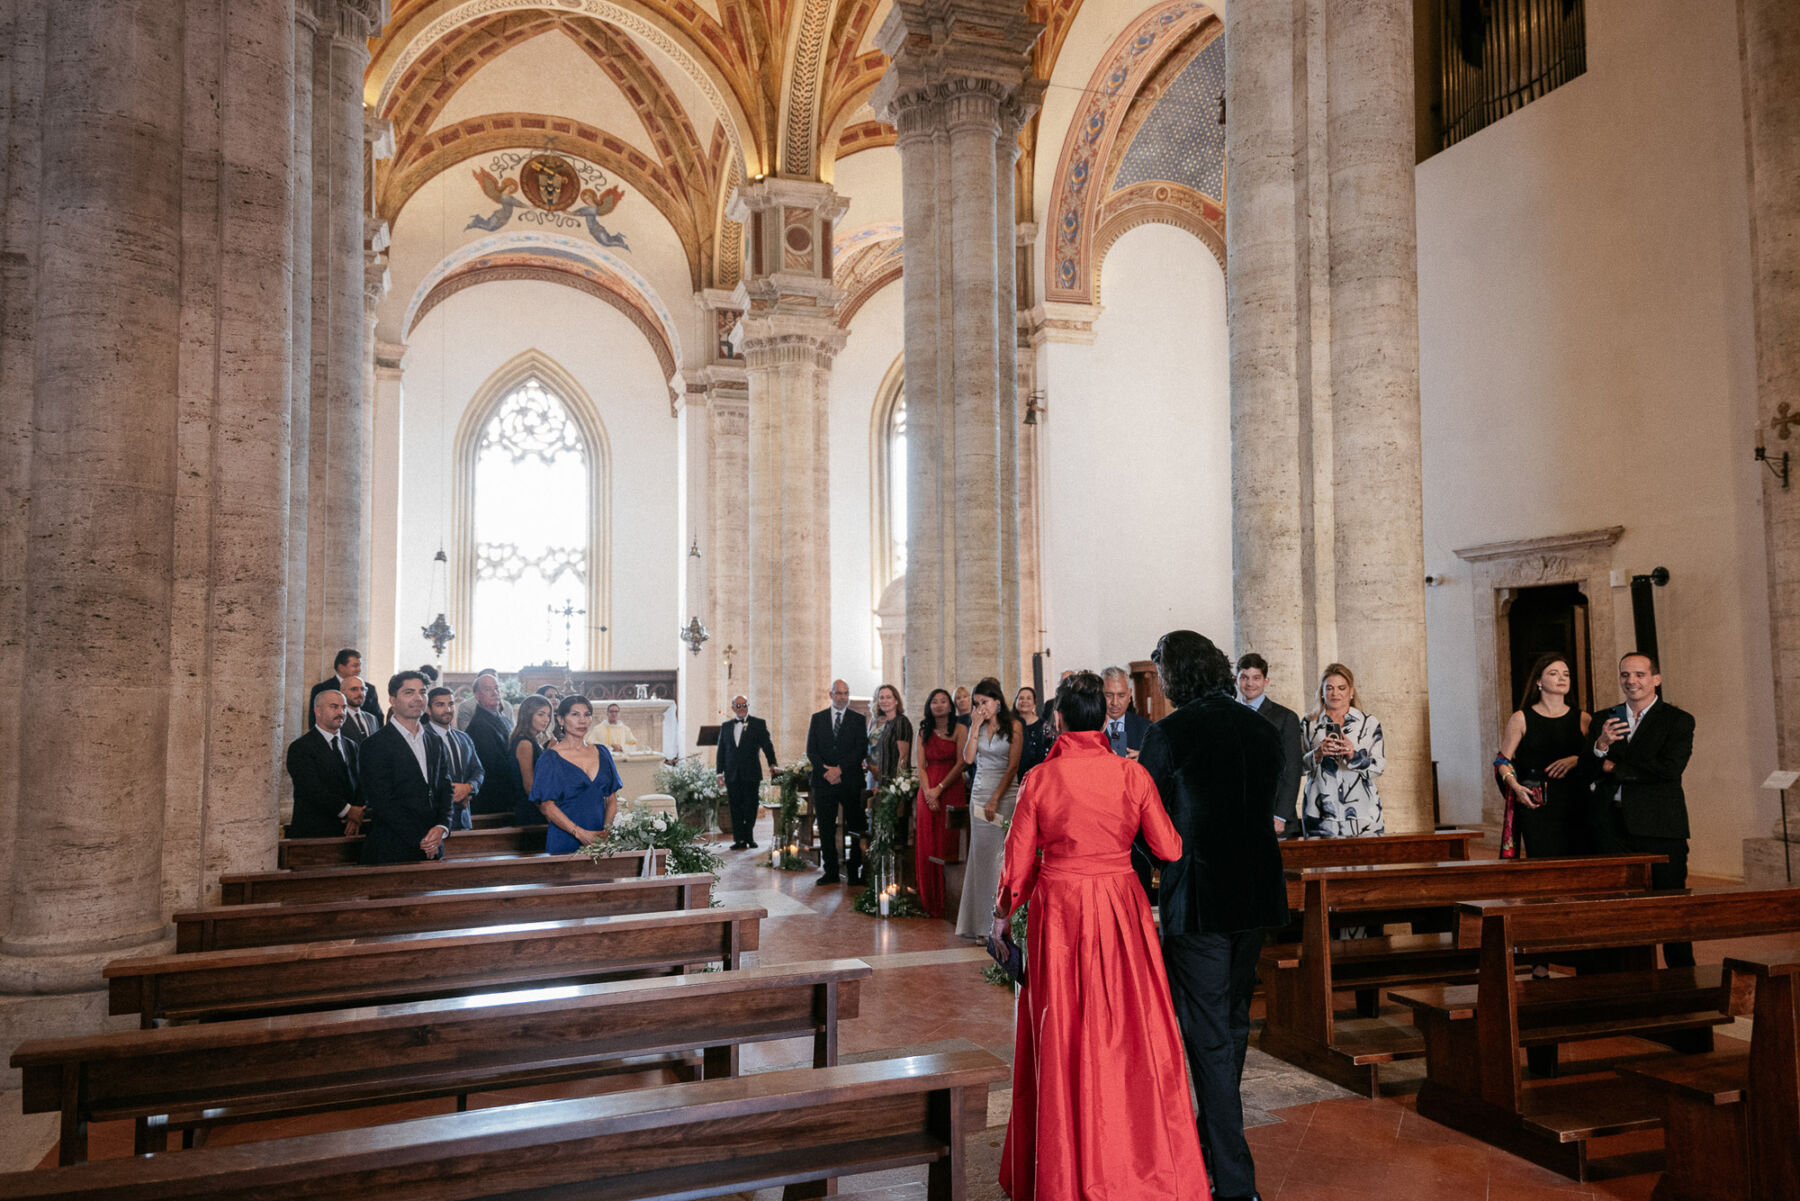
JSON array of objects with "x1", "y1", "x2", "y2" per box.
[{"x1": 387, "y1": 281, "x2": 686, "y2": 670}]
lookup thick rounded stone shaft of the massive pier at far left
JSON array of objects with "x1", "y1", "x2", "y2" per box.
[{"x1": 0, "y1": 0, "x2": 185, "y2": 992}]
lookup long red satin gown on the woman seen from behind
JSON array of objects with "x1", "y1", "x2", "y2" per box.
[{"x1": 995, "y1": 731, "x2": 1210, "y2": 1201}]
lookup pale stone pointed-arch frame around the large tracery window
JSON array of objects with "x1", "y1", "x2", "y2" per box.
[{"x1": 446, "y1": 348, "x2": 612, "y2": 672}]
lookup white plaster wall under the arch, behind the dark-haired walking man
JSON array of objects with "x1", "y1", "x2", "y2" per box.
[{"x1": 1040, "y1": 225, "x2": 1231, "y2": 679}]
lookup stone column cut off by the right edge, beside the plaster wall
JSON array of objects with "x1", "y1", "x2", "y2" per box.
[{"x1": 1739, "y1": 0, "x2": 1800, "y2": 882}]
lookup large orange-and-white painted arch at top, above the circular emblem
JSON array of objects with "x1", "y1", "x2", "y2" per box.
[{"x1": 364, "y1": 0, "x2": 769, "y2": 175}]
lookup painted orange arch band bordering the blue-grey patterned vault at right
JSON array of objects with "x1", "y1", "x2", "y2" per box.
[{"x1": 1044, "y1": 0, "x2": 1217, "y2": 304}]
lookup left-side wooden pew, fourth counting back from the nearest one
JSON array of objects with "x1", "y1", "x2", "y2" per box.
[{"x1": 175, "y1": 871, "x2": 713, "y2": 954}]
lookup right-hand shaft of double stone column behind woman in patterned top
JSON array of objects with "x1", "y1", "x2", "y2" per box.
[{"x1": 1317, "y1": 0, "x2": 1431, "y2": 834}]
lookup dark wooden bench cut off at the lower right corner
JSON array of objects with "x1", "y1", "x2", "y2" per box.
[{"x1": 1622, "y1": 949, "x2": 1800, "y2": 1201}]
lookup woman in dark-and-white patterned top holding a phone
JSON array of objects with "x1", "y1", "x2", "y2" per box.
[{"x1": 1300, "y1": 663, "x2": 1388, "y2": 839}]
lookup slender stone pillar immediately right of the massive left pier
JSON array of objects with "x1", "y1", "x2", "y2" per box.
[{"x1": 306, "y1": 0, "x2": 385, "y2": 679}]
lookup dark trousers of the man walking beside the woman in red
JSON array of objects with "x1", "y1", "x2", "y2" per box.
[{"x1": 1163, "y1": 929, "x2": 1264, "y2": 1201}]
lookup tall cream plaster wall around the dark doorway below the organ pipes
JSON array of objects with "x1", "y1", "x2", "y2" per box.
[{"x1": 1417, "y1": 0, "x2": 1775, "y2": 875}]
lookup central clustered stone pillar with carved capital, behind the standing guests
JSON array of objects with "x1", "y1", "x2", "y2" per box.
[{"x1": 873, "y1": 0, "x2": 1042, "y2": 704}]
